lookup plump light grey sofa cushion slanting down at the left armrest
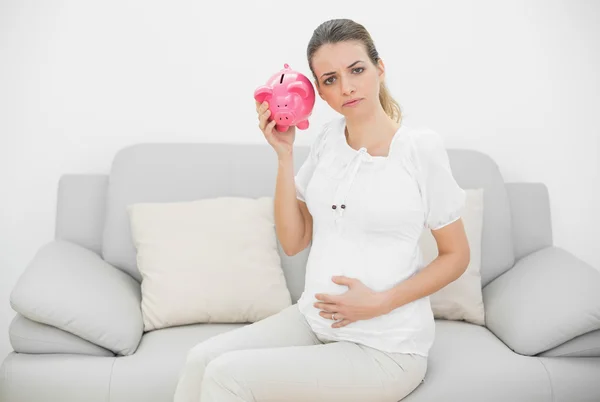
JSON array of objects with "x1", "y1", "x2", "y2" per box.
[{"x1": 10, "y1": 240, "x2": 144, "y2": 355}]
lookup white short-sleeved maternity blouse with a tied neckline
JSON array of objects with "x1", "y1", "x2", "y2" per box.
[{"x1": 295, "y1": 117, "x2": 466, "y2": 356}]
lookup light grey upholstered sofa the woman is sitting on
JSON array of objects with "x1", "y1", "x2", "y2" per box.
[{"x1": 0, "y1": 143, "x2": 600, "y2": 402}]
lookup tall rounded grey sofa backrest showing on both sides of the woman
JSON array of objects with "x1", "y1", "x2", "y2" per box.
[{"x1": 97, "y1": 143, "x2": 514, "y2": 296}]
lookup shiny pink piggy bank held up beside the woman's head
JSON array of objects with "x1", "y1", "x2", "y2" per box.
[{"x1": 254, "y1": 64, "x2": 315, "y2": 132}]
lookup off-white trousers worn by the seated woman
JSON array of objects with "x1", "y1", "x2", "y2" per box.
[{"x1": 174, "y1": 304, "x2": 427, "y2": 402}]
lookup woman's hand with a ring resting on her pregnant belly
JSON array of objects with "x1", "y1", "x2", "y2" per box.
[{"x1": 314, "y1": 276, "x2": 385, "y2": 328}]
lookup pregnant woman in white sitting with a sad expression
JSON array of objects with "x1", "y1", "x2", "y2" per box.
[{"x1": 175, "y1": 19, "x2": 470, "y2": 402}]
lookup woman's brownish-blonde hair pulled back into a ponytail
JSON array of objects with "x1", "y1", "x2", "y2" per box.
[{"x1": 306, "y1": 18, "x2": 402, "y2": 122}]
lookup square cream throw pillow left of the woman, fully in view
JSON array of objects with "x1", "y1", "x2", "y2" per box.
[{"x1": 128, "y1": 197, "x2": 291, "y2": 331}]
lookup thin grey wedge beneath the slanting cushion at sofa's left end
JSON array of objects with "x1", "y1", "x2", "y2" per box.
[{"x1": 9, "y1": 314, "x2": 114, "y2": 356}]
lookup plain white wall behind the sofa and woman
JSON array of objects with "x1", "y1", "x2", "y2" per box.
[{"x1": 0, "y1": 0, "x2": 600, "y2": 358}]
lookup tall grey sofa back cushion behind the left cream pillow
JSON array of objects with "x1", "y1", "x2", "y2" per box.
[{"x1": 102, "y1": 143, "x2": 308, "y2": 289}]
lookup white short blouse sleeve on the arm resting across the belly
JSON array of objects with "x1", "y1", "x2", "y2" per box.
[{"x1": 416, "y1": 130, "x2": 466, "y2": 230}]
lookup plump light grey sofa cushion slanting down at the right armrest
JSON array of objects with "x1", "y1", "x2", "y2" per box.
[{"x1": 483, "y1": 246, "x2": 600, "y2": 356}]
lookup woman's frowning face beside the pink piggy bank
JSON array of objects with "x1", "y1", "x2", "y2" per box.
[{"x1": 312, "y1": 41, "x2": 384, "y2": 117}]
